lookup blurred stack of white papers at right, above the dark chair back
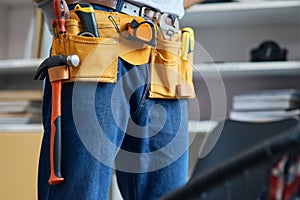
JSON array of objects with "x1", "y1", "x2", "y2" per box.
[{"x1": 229, "y1": 89, "x2": 300, "y2": 122}]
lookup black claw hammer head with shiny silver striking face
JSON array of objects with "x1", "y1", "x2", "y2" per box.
[{"x1": 33, "y1": 55, "x2": 79, "y2": 80}]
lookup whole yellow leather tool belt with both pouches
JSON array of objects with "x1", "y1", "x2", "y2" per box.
[{"x1": 51, "y1": 10, "x2": 195, "y2": 99}]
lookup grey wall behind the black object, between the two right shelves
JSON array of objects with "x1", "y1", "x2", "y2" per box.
[{"x1": 195, "y1": 25, "x2": 300, "y2": 63}]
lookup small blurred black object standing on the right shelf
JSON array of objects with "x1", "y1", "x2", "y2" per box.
[{"x1": 250, "y1": 40, "x2": 288, "y2": 62}]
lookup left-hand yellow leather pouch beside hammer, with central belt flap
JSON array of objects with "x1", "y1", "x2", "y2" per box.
[{"x1": 51, "y1": 10, "x2": 151, "y2": 83}]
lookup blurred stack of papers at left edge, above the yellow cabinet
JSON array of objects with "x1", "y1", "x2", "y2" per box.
[{"x1": 0, "y1": 90, "x2": 42, "y2": 124}]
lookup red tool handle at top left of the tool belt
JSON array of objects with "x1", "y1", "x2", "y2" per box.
[{"x1": 53, "y1": 0, "x2": 68, "y2": 33}]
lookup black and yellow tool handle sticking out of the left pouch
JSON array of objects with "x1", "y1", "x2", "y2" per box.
[{"x1": 74, "y1": 2, "x2": 99, "y2": 37}]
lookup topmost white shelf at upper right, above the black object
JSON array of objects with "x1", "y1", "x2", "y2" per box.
[{"x1": 181, "y1": 0, "x2": 300, "y2": 27}]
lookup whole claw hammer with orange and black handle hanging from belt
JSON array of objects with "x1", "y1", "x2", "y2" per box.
[{"x1": 33, "y1": 55, "x2": 79, "y2": 185}]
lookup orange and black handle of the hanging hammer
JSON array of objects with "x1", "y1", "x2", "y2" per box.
[{"x1": 48, "y1": 80, "x2": 64, "y2": 185}]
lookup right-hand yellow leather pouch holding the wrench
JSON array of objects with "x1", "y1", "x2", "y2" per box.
[{"x1": 149, "y1": 30, "x2": 195, "y2": 99}]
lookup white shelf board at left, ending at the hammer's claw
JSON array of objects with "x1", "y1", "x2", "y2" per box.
[{"x1": 0, "y1": 59, "x2": 44, "y2": 74}]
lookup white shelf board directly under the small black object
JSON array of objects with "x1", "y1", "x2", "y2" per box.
[{"x1": 194, "y1": 61, "x2": 300, "y2": 76}]
